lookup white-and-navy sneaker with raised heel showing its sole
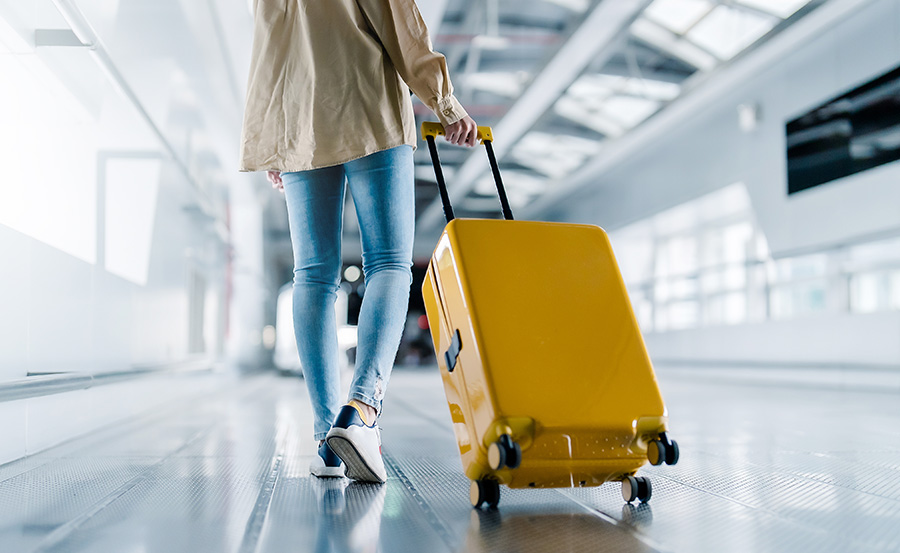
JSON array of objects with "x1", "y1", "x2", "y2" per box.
[{"x1": 325, "y1": 403, "x2": 387, "y2": 483}]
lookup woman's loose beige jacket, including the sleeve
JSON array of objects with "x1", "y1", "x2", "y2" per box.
[{"x1": 240, "y1": 0, "x2": 466, "y2": 171}]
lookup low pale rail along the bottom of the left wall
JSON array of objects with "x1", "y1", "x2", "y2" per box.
[{"x1": 0, "y1": 359, "x2": 214, "y2": 403}]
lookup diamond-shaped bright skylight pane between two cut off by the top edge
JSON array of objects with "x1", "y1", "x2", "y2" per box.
[{"x1": 687, "y1": 5, "x2": 778, "y2": 60}]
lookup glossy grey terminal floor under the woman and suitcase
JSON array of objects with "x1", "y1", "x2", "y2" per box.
[{"x1": 0, "y1": 369, "x2": 900, "y2": 553}]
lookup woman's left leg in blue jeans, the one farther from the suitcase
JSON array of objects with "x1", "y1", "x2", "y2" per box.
[{"x1": 281, "y1": 166, "x2": 344, "y2": 440}]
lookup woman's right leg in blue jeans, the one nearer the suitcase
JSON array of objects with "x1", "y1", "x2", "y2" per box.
[{"x1": 344, "y1": 145, "x2": 416, "y2": 413}]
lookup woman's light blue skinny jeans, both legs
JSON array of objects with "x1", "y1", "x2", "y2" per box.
[{"x1": 281, "y1": 145, "x2": 415, "y2": 440}]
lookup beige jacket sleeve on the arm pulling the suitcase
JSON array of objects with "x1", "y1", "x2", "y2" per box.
[{"x1": 357, "y1": 0, "x2": 468, "y2": 126}]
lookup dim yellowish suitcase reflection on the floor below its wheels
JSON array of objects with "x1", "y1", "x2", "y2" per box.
[{"x1": 463, "y1": 504, "x2": 654, "y2": 553}]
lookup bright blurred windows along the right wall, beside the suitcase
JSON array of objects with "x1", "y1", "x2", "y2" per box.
[{"x1": 610, "y1": 179, "x2": 900, "y2": 332}]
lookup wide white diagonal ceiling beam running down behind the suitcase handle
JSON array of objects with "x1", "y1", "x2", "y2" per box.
[{"x1": 417, "y1": 0, "x2": 650, "y2": 229}]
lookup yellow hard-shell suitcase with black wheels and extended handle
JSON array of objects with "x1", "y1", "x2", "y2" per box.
[{"x1": 422, "y1": 123, "x2": 678, "y2": 507}]
